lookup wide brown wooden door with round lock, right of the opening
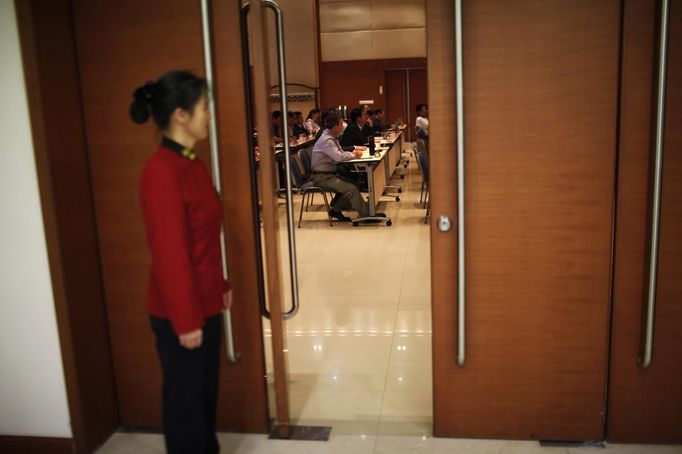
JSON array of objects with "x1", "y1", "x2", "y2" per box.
[{"x1": 427, "y1": 0, "x2": 620, "y2": 440}]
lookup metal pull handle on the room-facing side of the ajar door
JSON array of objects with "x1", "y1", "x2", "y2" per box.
[{"x1": 242, "y1": 0, "x2": 300, "y2": 320}]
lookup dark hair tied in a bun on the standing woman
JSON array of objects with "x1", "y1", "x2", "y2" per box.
[{"x1": 129, "y1": 71, "x2": 208, "y2": 129}]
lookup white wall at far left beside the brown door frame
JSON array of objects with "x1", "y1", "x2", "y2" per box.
[{"x1": 0, "y1": 0, "x2": 72, "y2": 438}]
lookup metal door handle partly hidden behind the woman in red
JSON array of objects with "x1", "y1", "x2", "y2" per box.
[{"x1": 201, "y1": 0, "x2": 239, "y2": 363}]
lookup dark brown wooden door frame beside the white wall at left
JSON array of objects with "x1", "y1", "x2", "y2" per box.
[{"x1": 15, "y1": 0, "x2": 120, "y2": 453}]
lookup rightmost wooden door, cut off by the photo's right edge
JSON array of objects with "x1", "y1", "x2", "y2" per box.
[{"x1": 607, "y1": 0, "x2": 682, "y2": 443}]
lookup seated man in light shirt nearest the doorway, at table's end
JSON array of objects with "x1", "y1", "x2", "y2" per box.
[{"x1": 311, "y1": 112, "x2": 369, "y2": 222}]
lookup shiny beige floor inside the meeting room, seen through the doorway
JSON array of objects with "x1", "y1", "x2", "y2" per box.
[{"x1": 265, "y1": 145, "x2": 432, "y2": 436}]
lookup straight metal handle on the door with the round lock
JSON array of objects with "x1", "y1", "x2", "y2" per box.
[{"x1": 455, "y1": 0, "x2": 466, "y2": 366}]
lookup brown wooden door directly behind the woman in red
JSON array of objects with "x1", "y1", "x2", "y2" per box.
[{"x1": 73, "y1": 0, "x2": 268, "y2": 432}]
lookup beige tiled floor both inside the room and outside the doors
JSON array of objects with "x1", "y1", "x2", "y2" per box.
[{"x1": 98, "y1": 150, "x2": 682, "y2": 454}]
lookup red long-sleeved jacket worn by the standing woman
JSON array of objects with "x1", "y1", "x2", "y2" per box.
[{"x1": 140, "y1": 138, "x2": 230, "y2": 334}]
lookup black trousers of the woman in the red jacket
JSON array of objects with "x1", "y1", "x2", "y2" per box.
[{"x1": 150, "y1": 315, "x2": 222, "y2": 454}]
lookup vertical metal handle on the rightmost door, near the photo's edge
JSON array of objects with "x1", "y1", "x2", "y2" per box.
[{"x1": 637, "y1": 0, "x2": 670, "y2": 369}]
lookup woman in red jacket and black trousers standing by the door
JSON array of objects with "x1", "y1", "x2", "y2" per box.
[{"x1": 130, "y1": 71, "x2": 232, "y2": 454}]
